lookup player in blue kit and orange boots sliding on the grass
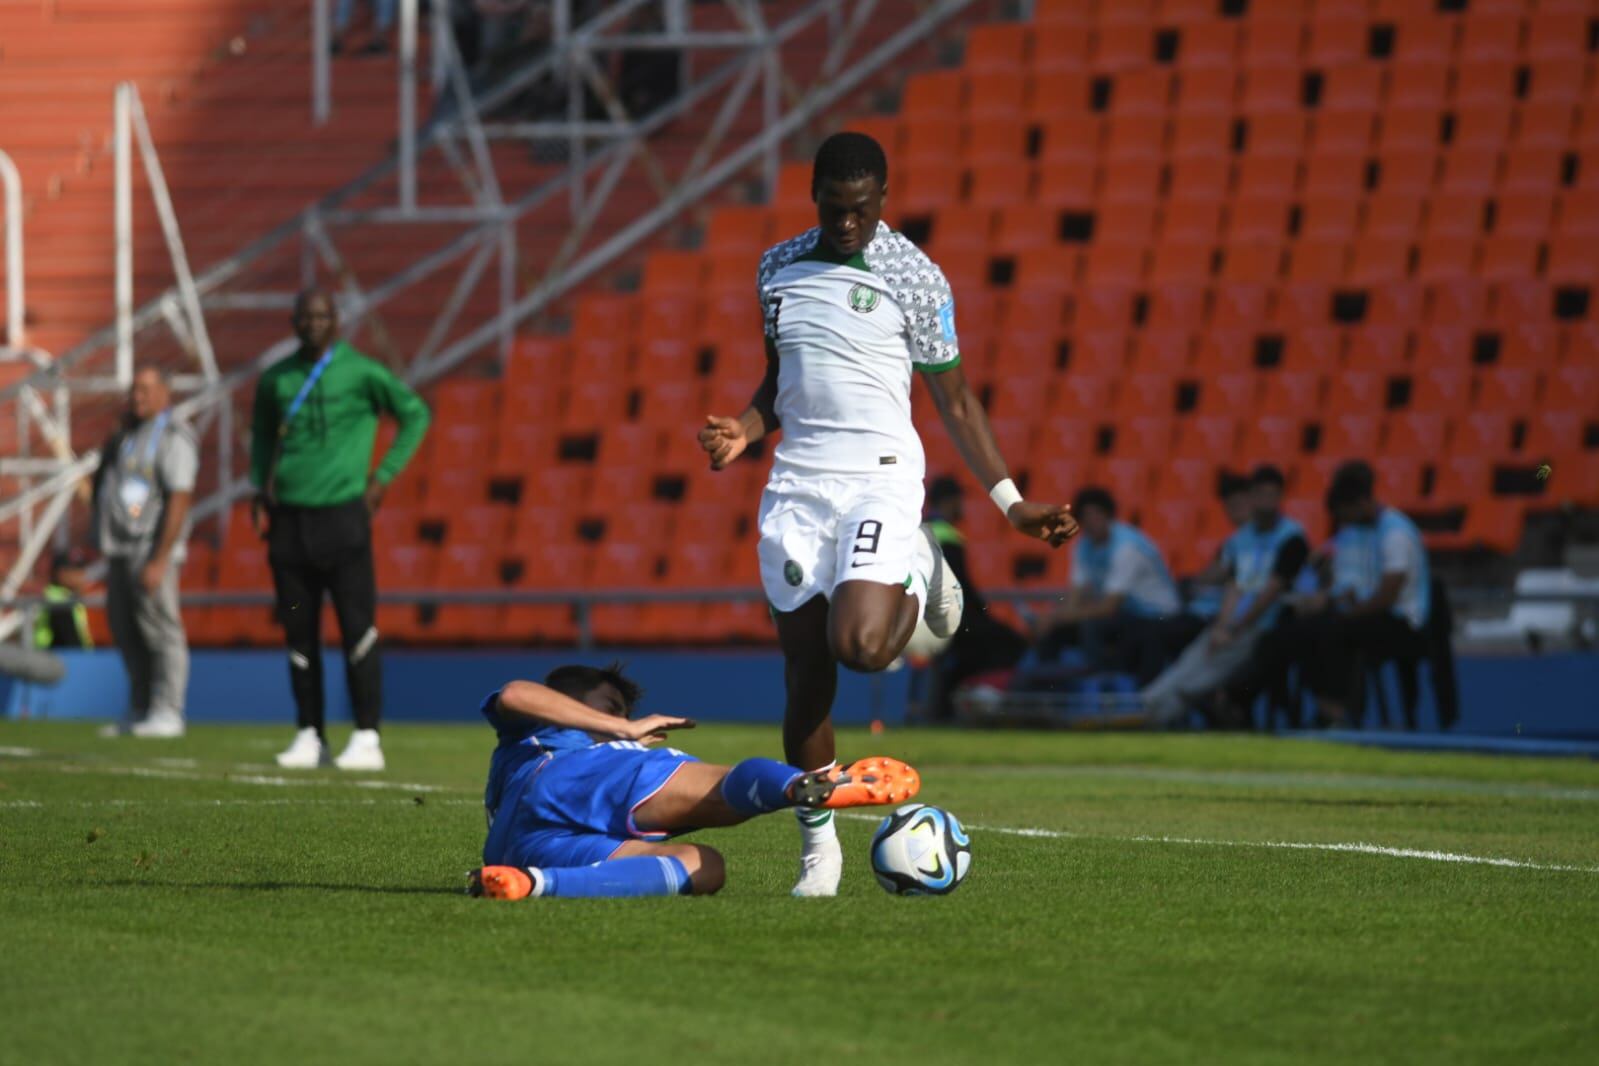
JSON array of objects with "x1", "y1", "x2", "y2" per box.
[{"x1": 469, "y1": 666, "x2": 921, "y2": 900}]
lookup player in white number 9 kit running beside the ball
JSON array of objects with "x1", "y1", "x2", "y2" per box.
[{"x1": 699, "y1": 133, "x2": 1076, "y2": 895}]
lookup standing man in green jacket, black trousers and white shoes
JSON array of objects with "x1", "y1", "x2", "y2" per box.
[{"x1": 249, "y1": 289, "x2": 429, "y2": 770}]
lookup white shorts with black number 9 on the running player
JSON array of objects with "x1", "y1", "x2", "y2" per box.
[{"x1": 760, "y1": 478, "x2": 923, "y2": 612}]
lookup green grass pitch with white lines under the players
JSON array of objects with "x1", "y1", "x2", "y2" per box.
[{"x1": 0, "y1": 722, "x2": 1599, "y2": 1064}]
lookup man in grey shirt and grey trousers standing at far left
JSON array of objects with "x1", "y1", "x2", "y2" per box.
[{"x1": 93, "y1": 368, "x2": 200, "y2": 737}]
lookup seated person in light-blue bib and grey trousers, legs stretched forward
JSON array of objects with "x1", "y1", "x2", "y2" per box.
[{"x1": 1140, "y1": 465, "x2": 1310, "y2": 726}]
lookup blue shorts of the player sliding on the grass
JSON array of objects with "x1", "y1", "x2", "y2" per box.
[{"x1": 483, "y1": 740, "x2": 697, "y2": 866}]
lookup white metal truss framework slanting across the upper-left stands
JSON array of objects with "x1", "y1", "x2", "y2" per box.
[{"x1": 0, "y1": 0, "x2": 974, "y2": 634}]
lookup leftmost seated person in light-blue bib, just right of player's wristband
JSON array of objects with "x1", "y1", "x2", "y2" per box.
[{"x1": 1036, "y1": 487, "x2": 1191, "y2": 684}]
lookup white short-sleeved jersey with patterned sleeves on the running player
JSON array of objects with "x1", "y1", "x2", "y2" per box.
[{"x1": 756, "y1": 222, "x2": 961, "y2": 481}]
